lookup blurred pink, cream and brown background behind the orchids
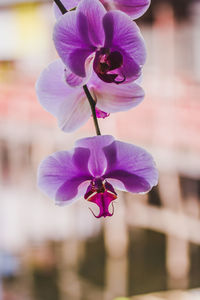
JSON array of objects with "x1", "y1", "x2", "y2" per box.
[{"x1": 0, "y1": 0, "x2": 200, "y2": 300}]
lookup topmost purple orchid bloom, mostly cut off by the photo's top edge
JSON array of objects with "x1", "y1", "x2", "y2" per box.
[{"x1": 54, "y1": 0, "x2": 151, "y2": 19}]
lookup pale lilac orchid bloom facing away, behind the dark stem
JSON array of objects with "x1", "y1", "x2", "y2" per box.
[{"x1": 36, "y1": 60, "x2": 144, "y2": 132}]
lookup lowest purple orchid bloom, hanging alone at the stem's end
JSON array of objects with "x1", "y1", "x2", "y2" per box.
[{"x1": 38, "y1": 135, "x2": 158, "y2": 218}]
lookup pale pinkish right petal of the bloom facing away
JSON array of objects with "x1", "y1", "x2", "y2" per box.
[{"x1": 89, "y1": 74, "x2": 144, "y2": 113}]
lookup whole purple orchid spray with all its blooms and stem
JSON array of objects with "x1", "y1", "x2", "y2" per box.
[{"x1": 36, "y1": 0, "x2": 158, "y2": 218}]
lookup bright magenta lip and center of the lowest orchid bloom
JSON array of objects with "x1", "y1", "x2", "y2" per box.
[{"x1": 84, "y1": 177, "x2": 117, "y2": 218}]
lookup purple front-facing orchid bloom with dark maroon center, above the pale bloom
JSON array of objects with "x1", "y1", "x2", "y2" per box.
[{"x1": 54, "y1": 0, "x2": 146, "y2": 84}]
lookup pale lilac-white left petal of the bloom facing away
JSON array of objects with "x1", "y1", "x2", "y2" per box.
[{"x1": 36, "y1": 60, "x2": 91, "y2": 132}]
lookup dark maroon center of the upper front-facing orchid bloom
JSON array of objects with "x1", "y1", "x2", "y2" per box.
[{"x1": 93, "y1": 48, "x2": 125, "y2": 84}]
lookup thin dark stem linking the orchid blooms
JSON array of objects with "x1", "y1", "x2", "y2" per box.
[{"x1": 54, "y1": 0, "x2": 101, "y2": 135}]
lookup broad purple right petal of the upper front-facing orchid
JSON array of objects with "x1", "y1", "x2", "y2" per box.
[{"x1": 103, "y1": 11, "x2": 146, "y2": 78}]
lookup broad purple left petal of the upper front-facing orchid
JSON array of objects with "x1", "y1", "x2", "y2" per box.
[{"x1": 53, "y1": 11, "x2": 94, "y2": 77}]
